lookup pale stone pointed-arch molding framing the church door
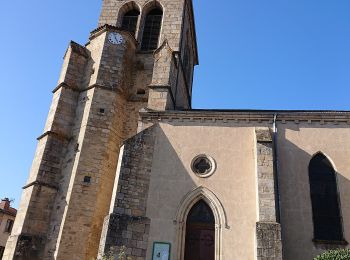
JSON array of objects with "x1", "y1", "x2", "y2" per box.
[{"x1": 174, "y1": 186, "x2": 230, "y2": 260}]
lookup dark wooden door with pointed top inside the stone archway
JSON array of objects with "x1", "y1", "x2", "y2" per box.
[{"x1": 185, "y1": 200, "x2": 215, "y2": 260}]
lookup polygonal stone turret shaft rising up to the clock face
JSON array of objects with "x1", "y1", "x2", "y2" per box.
[{"x1": 48, "y1": 27, "x2": 136, "y2": 259}]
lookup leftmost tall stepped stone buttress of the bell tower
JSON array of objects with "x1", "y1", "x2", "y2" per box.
[{"x1": 4, "y1": 42, "x2": 88, "y2": 259}]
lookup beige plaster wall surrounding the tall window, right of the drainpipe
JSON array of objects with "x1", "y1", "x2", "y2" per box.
[{"x1": 277, "y1": 122, "x2": 350, "y2": 260}]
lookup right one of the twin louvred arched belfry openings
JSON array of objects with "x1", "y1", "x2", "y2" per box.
[{"x1": 141, "y1": 8, "x2": 163, "y2": 51}]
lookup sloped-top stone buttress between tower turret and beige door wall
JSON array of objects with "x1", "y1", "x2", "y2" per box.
[{"x1": 99, "y1": 127, "x2": 156, "y2": 260}]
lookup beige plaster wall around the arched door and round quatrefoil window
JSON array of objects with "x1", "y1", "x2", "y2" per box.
[{"x1": 147, "y1": 123, "x2": 257, "y2": 260}]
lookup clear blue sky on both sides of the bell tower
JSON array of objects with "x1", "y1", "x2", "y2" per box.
[{"x1": 0, "y1": 0, "x2": 350, "y2": 206}]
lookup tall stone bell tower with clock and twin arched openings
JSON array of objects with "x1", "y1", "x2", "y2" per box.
[{"x1": 3, "y1": 0, "x2": 198, "y2": 260}]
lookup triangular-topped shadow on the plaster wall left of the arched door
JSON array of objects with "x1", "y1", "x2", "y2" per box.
[{"x1": 147, "y1": 125, "x2": 204, "y2": 259}]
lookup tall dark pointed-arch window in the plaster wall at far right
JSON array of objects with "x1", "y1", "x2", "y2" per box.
[{"x1": 309, "y1": 153, "x2": 344, "y2": 241}]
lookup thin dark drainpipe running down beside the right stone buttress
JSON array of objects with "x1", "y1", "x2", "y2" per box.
[{"x1": 272, "y1": 113, "x2": 281, "y2": 223}]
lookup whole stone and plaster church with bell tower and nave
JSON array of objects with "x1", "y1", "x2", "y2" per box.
[{"x1": 3, "y1": 0, "x2": 350, "y2": 260}]
